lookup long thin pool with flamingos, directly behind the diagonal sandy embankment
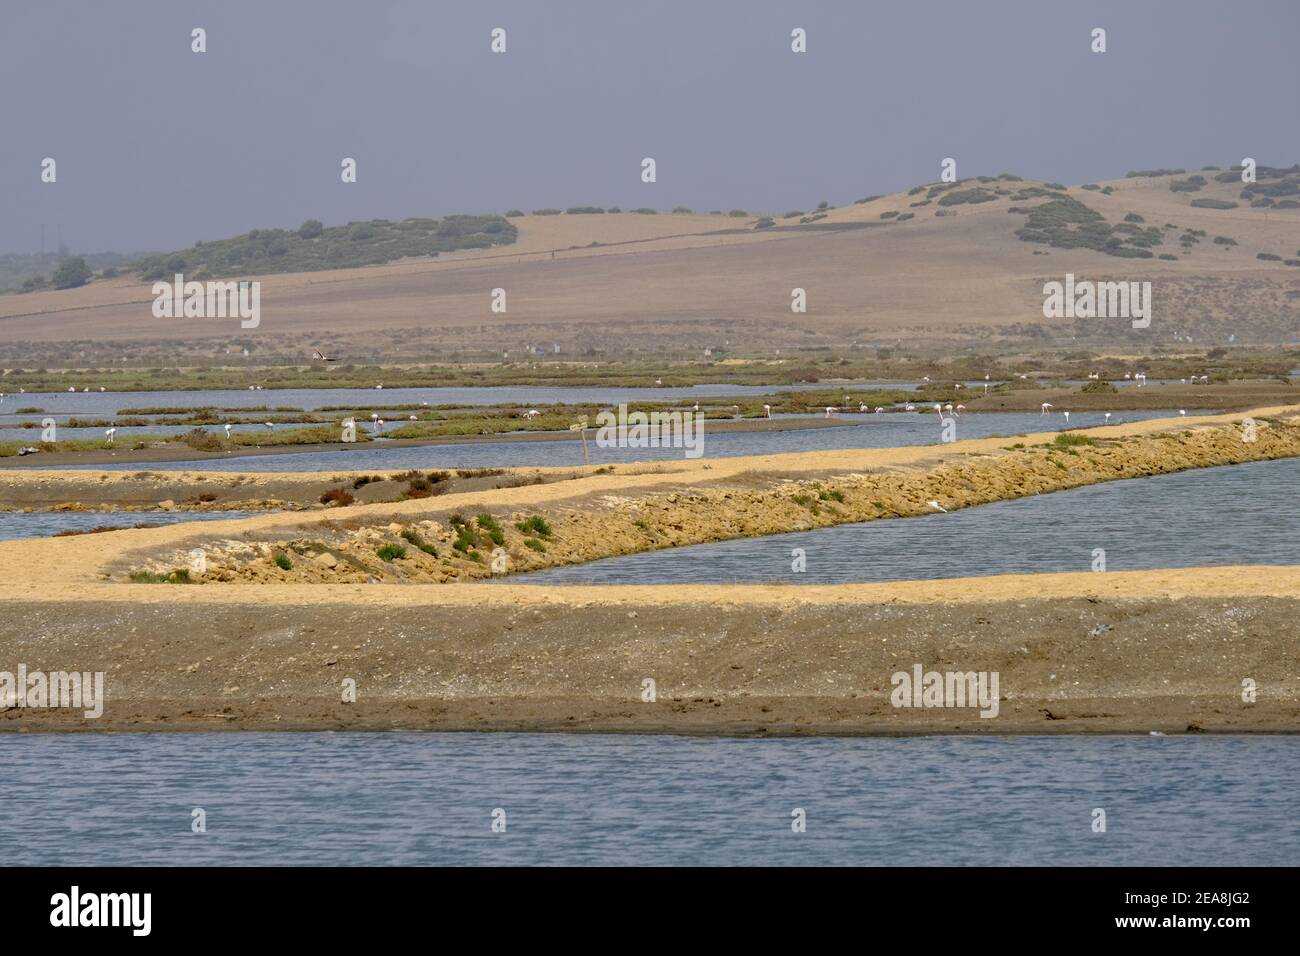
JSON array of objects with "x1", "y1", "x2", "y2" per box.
[{"x1": 31, "y1": 408, "x2": 1212, "y2": 471}]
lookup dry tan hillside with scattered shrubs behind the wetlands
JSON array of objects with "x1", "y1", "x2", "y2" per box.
[{"x1": 0, "y1": 172, "x2": 1300, "y2": 364}]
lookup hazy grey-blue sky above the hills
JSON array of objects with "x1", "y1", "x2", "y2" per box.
[{"x1": 0, "y1": 0, "x2": 1300, "y2": 251}]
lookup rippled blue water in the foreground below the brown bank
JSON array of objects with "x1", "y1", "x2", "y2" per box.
[{"x1": 0, "y1": 732, "x2": 1300, "y2": 866}]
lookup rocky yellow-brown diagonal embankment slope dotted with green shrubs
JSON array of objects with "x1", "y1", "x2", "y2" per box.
[{"x1": 103, "y1": 416, "x2": 1300, "y2": 584}]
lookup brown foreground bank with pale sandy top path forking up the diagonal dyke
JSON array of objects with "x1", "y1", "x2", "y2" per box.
[{"x1": 0, "y1": 407, "x2": 1300, "y2": 734}]
